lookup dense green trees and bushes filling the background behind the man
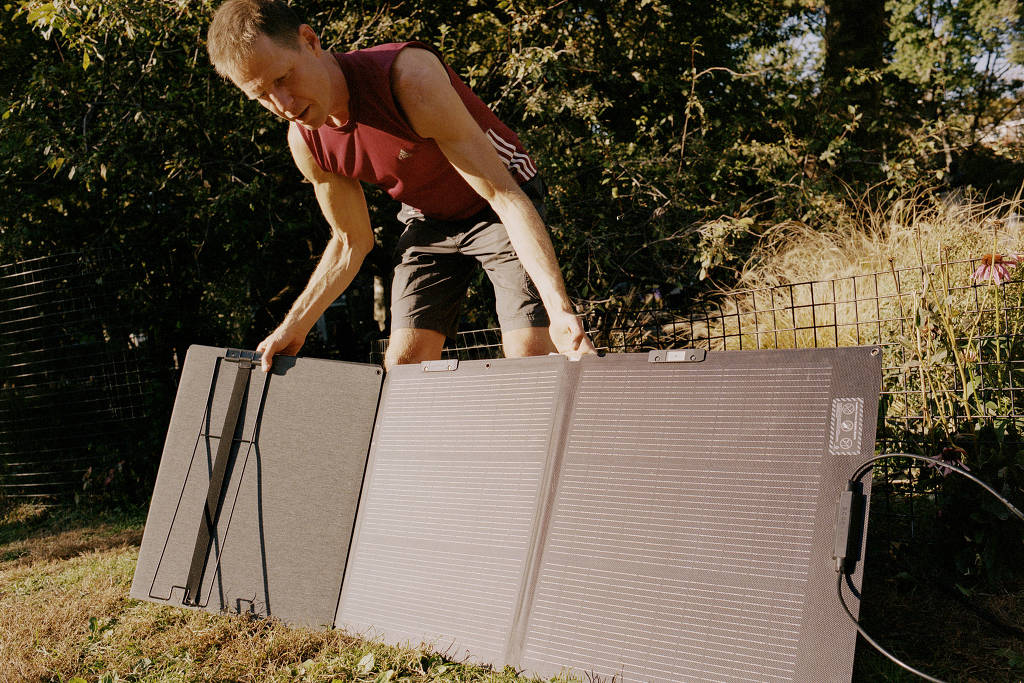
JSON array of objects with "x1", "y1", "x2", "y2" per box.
[{"x1": 0, "y1": 0, "x2": 1022, "y2": 339}]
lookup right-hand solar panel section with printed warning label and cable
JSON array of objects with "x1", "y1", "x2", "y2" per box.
[{"x1": 517, "y1": 348, "x2": 881, "y2": 683}]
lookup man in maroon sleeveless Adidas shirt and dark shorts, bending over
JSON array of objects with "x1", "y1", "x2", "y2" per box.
[{"x1": 207, "y1": 0, "x2": 594, "y2": 371}]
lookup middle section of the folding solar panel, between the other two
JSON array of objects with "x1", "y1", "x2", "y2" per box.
[{"x1": 336, "y1": 356, "x2": 568, "y2": 663}]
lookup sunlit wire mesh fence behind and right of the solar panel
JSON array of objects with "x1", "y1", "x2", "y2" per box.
[{"x1": 373, "y1": 255, "x2": 1024, "y2": 539}]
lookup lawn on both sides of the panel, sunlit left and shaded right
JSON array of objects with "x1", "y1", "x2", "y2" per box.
[{"x1": 0, "y1": 499, "x2": 1024, "y2": 683}]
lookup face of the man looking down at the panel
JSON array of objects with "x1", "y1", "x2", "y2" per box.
[{"x1": 230, "y1": 26, "x2": 332, "y2": 130}]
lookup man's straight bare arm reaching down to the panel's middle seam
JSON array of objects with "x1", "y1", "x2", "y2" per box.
[{"x1": 391, "y1": 48, "x2": 594, "y2": 353}]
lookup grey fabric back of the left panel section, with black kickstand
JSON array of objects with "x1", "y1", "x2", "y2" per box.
[{"x1": 131, "y1": 346, "x2": 382, "y2": 626}]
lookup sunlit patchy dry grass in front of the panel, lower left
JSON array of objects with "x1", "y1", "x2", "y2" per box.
[{"x1": 0, "y1": 506, "x2": 580, "y2": 683}]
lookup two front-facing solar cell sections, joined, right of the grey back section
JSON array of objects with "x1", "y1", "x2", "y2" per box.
[{"x1": 336, "y1": 348, "x2": 881, "y2": 682}]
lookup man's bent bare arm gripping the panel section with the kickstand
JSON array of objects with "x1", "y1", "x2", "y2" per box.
[{"x1": 256, "y1": 125, "x2": 374, "y2": 372}]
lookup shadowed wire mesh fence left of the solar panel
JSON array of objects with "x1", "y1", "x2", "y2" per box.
[{"x1": 0, "y1": 251, "x2": 155, "y2": 499}]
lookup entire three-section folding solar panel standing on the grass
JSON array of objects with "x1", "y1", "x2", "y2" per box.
[{"x1": 132, "y1": 347, "x2": 881, "y2": 682}]
